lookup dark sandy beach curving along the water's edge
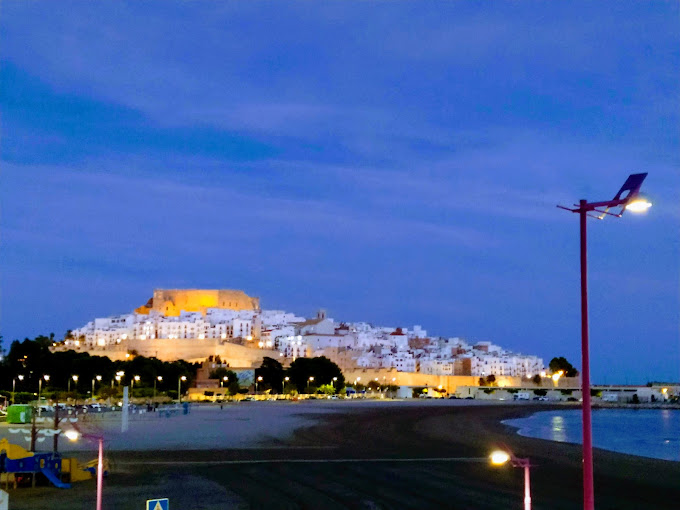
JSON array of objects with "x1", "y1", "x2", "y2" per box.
[{"x1": 5, "y1": 401, "x2": 680, "y2": 510}]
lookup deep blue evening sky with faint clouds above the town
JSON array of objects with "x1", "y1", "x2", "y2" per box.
[{"x1": 0, "y1": 0, "x2": 680, "y2": 383}]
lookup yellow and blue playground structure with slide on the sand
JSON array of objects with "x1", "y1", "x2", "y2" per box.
[{"x1": 0, "y1": 438, "x2": 101, "y2": 490}]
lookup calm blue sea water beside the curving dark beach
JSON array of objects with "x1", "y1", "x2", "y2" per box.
[{"x1": 503, "y1": 409, "x2": 680, "y2": 461}]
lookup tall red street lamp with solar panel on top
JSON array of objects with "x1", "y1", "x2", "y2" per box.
[{"x1": 557, "y1": 173, "x2": 652, "y2": 510}]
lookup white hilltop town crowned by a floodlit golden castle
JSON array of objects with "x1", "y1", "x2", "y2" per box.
[{"x1": 53, "y1": 289, "x2": 545, "y2": 378}]
